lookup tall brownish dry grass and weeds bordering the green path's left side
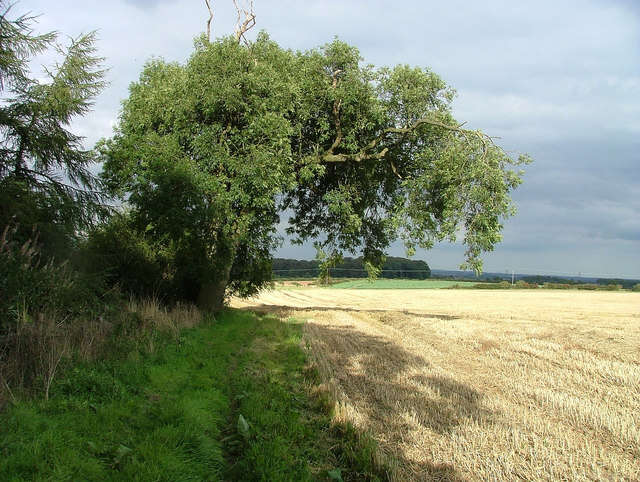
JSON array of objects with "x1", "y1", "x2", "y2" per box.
[{"x1": 0, "y1": 226, "x2": 201, "y2": 407}]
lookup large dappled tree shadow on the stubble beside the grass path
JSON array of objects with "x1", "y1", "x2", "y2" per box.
[{"x1": 305, "y1": 321, "x2": 493, "y2": 480}]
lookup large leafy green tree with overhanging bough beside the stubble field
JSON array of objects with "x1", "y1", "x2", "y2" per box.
[{"x1": 101, "y1": 33, "x2": 527, "y2": 309}]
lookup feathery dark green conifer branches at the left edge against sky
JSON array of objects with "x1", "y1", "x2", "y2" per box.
[{"x1": 0, "y1": 0, "x2": 104, "y2": 255}]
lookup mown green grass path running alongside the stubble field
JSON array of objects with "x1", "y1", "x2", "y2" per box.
[{"x1": 0, "y1": 311, "x2": 382, "y2": 481}]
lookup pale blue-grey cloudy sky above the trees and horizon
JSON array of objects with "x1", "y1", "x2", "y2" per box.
[{"x1": 14, "y1": 0, "x2": 640, "y2": 278}]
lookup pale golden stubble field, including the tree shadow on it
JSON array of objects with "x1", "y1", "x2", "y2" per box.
[{"x1": 234, "y1": 288, "x2": 640, "y2": 480}]
